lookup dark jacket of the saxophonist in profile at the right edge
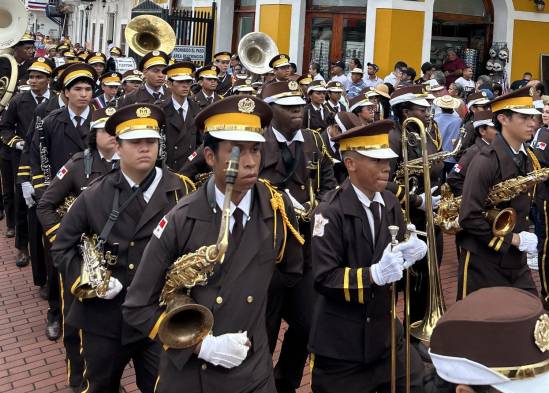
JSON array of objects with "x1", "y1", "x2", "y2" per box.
[{"x1": 457, "y1": 134, "x2": 533, "y2": 269}]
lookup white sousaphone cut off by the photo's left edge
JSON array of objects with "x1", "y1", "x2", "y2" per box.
[{"x1": 0, "y1": 0, "x2": 28, "y2": 112}]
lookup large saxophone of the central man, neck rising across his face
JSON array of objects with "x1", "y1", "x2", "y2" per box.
[{"x1": 158, "y1": 146, "x2": 240, "y2": 349}]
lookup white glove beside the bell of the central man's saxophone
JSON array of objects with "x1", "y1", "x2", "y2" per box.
[{"x1": 198, "y1": 332, "x2": 250, "y2": 368}]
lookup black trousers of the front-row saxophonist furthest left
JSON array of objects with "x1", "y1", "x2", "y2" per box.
[{"x1": 82, "y1": 332, "x2": 161, "y2": 393}]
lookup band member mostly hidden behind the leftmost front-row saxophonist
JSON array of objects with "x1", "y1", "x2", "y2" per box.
[{"x1": 36, "y1": 107, "x2": 118, "y2": 392}]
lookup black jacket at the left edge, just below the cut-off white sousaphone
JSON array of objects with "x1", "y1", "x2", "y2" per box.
[{"x1": 0, "y1": 91, "x2": 37, "y2": 161}]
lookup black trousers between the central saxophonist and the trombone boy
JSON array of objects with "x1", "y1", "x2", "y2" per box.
[{"x1": 267, "y1": 267, "x2": 315, "y2": 393}]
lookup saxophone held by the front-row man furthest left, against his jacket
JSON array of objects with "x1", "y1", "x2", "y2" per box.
[{"x1": 74, "y1": 234, "x2": 118, "y2": 299}]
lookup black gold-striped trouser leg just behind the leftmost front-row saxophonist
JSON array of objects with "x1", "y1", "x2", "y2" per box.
[{"x1": 59, "y1": 274, "x2": 84, "y2": 387}]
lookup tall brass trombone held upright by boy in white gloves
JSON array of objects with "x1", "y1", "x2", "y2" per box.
[{"x1": 398, "y1": 117, "x2": 446, "y2": 393}]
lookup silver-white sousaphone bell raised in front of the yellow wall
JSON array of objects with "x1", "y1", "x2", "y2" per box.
[{"x1": 238, "y1": 32, "x2": 278, "y2": 75}]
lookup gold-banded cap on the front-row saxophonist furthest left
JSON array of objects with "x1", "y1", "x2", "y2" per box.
[{"x1": 105, "y1": 104, "x2": 165, "y2": 139}]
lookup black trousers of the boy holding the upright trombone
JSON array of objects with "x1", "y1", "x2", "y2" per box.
[{"x1": 311, "y1": 334, "x2": 423, "y2": 393}]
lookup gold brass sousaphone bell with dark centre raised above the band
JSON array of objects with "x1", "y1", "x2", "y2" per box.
[{"x1": 124, "y1": 15, "x2": 176, "y2": 56}]
